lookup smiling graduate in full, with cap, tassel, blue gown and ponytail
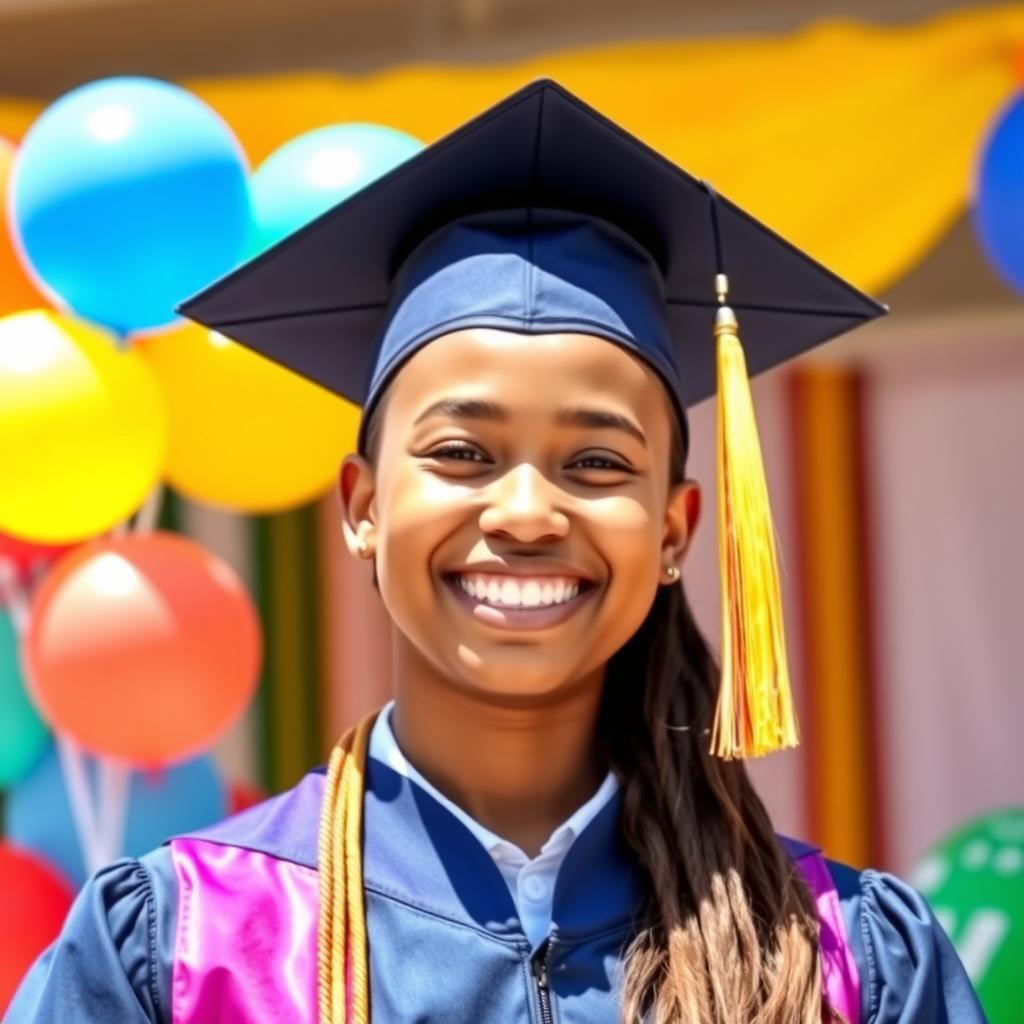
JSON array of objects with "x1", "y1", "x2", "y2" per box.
[{"x1": 9, "y1": 81, "x2": 983, "y2": 1024}]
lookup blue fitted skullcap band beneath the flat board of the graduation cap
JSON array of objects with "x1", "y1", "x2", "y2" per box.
[{"x1": 364, "y1": 207, "x2": 685, "y2": 444}]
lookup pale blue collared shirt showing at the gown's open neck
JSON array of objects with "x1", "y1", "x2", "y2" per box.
[{"x1": 369, "y1": 700, "x2": 618, "y2": 948}]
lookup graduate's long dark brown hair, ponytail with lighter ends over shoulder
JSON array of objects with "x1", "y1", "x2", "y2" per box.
[{"x1": 364, "y1": 387, "x2": 838, "y2": 1024}]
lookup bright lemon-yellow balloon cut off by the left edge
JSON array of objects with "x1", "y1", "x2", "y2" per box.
[{"x1": 0, "y1": 310, "x2": 166, "y2": 544}]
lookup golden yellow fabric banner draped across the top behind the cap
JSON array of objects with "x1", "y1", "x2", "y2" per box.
[{"x1": 0, "y1": 4, "x2": 1024, "y2": 291}]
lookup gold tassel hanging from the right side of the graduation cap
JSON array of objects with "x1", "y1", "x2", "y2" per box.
[{"x1": 712, "y1": 274, "x2": 799, "y2": 760}]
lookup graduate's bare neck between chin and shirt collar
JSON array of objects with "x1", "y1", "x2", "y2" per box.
[{"x1": 391, "y1": 656, "x2": 606, "y2": 856}]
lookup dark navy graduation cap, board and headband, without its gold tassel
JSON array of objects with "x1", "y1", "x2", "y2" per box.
[{"x1": 177, "y1": 79, "x2": 885, "y2": 423}]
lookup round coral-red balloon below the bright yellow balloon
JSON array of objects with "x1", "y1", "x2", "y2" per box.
[{"x1": 24, "y1": 532, "x2": 261, "y2": 768}]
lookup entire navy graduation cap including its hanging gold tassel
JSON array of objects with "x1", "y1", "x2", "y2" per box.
[{"x1": 177, "y1": 79, "x2": 886, "y2": 770}]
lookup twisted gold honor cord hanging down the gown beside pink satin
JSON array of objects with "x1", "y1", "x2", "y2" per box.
[{"x1": 316, "y1": 712, "x2": 377, "y2": 1024}]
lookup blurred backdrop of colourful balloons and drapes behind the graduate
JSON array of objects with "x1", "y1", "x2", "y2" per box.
[{"x1": 0, "y1": 0, "x2": 1024, "y2": 1021}]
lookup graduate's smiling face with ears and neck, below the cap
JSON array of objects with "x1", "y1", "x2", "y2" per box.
[{"x1": 341, "y1": 329, "x2": 699, "y2": 856}]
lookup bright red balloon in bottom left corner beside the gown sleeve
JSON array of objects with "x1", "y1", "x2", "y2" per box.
[{"x1": 0, "y1": 842, "x2": 74, "y2": 1017}]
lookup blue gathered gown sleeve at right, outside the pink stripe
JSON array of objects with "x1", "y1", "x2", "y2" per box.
[{"x1": 810, "y1": 848, "x2": 985, "y2": 1024}]
